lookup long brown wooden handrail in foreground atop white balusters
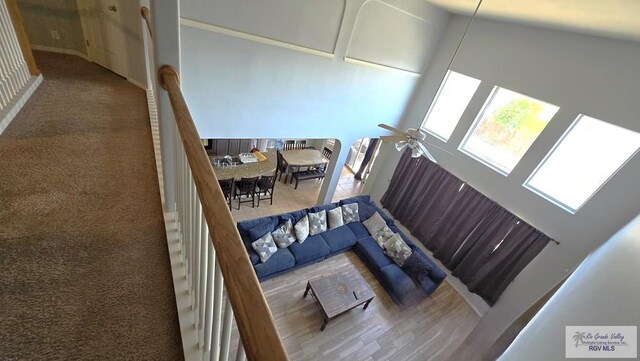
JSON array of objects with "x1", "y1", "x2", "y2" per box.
[{"x1": 158, "y1": 65, "x2": 288, "y2": 361}]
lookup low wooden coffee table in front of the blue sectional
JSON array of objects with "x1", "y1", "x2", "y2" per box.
[{"x1": 302, "y1": 267, "x2": 375, "y2": 331}]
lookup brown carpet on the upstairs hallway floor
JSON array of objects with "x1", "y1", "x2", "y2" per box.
[{"x1": 0, "y1": 52, "x2": 183, "y2": 360}]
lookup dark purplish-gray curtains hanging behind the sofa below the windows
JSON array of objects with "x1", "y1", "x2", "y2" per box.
[{"x1": 380, "y1": 151, "x2": 550, "y2": 305}]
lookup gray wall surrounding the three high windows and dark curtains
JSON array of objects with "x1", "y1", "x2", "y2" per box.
[{"x1": 365, "y1": 16, "x2": 640, "y2": 342}]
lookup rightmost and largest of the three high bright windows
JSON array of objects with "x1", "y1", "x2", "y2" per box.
[{"x1": 524, "y1": 115, "x2": 640, "y2": 213}]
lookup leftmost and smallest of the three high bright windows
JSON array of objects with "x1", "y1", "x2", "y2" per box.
[{"x1": 422, "y1": 70, "x2": 480, "y2": 142}]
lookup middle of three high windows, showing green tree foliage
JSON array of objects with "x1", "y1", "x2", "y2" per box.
[{"x1": 460, "y1": 87, "x2": 559, "y2": 175}]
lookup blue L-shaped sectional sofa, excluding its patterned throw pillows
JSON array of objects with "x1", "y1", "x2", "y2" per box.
[{"x1": 237, "y1": 195, "x2": 446, "y2": 303}]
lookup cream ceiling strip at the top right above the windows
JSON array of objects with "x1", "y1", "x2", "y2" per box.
[{"x1": 426, "y1": 0, "x2": 640, "y2": 41}]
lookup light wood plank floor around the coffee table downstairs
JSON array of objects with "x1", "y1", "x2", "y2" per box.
[{"x1": 262, "y1": 251, "x2": 479, "y2": 361}]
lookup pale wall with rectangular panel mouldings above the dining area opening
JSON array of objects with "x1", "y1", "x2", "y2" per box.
[{"x1": 180, "y1": 0, "x2": 448, "y2": 202}]
